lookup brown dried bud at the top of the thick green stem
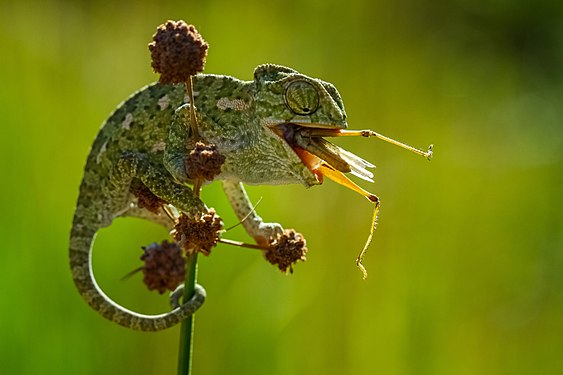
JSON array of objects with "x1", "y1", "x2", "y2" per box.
[{"x1": 173, "y1": 208, "x2": 223, "y2": 256}]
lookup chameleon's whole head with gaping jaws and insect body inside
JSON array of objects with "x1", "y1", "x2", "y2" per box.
[{"x1": 249, "y1": 64, "x2": 372, "y2": 186}]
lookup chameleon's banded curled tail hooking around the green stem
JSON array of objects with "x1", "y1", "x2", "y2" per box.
[{"x1": 69, "y1": 215, "x2": 205, "y2": 331}]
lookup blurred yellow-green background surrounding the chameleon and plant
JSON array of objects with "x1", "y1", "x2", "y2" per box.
[{"x1": 0, "y1": 0, "x2": 563, "y2": 374}]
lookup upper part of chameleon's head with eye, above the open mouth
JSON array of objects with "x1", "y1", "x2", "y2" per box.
[{"x1": 254, "y1": 64, "x2": 347, "y2": 129}]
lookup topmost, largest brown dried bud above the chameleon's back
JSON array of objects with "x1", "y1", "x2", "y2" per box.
[{"x1": 149, "y1": 21, "x2": 209, "y2": 84}]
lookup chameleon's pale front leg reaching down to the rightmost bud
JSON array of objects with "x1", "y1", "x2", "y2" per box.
[{"x1": 223, "y1": 181, "x2": 283, "y2": 245}]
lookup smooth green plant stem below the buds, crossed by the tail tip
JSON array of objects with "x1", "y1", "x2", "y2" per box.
[{"x1": 178, "y1": 253, "x2": 197, "y2": 375}]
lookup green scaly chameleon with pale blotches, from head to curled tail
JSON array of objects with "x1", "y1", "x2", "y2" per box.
[{"x1": 70, "y1": 65, "x2": 346, "y2": 331}]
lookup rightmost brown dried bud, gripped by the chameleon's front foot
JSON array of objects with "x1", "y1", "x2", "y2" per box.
[{"x1": 264, "y1": 229, "x2": 307, "y2": 273}]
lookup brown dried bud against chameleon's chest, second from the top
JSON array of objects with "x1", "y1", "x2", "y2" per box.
[{"x1": 185, "y1": 142, "x2": 225, "y2": 181}]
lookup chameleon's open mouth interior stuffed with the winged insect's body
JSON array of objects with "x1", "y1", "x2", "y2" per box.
[{"x1": 274, "y1": 123, "x2": 375, "y2": 190}]
